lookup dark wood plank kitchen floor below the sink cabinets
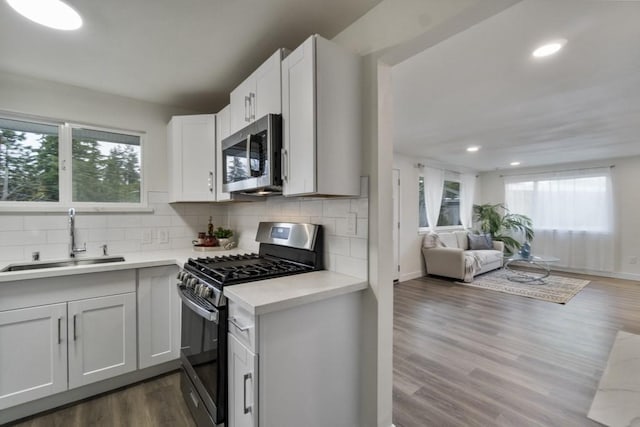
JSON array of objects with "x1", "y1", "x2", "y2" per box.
[{"x1": 11, "y1": 372, "x2": 195, "y2": 427}]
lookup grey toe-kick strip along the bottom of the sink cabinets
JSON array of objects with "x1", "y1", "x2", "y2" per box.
[{"x1": 0, "y1": 359, "x2": 180, "y2": 425}]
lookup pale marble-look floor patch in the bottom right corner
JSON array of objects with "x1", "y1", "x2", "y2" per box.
[{"x1": 587, "y1": 331, "x2": 640, "y2": 426}]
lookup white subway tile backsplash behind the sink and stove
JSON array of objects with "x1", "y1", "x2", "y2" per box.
[{"x1": 0, "y1": 191, "x2": 368, "y2": 277}]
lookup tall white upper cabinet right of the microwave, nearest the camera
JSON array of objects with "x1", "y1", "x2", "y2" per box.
[{"x1": 282, "y1": 35, "x2": 362, "y2": 196}]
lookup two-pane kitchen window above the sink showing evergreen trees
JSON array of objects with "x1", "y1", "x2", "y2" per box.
[{"x1": 0, "y1": 117, "x2": 144, "y2": 209}]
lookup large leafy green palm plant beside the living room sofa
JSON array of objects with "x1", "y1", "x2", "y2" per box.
[{"x1": 473, "y1": 203, "x2": 534, "y2": 254}]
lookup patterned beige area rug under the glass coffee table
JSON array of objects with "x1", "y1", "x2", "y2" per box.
[{"x1": 456, "y1": 269, "x2": 589, "y2": 304}]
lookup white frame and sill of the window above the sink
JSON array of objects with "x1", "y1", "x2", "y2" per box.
[{"x1": 0, "y1": 112, "x2": 146, "y2": 212}]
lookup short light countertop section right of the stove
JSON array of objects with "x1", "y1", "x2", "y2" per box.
[{"x1": 224, "y1": 270, "x2": 369, "y2": 315}]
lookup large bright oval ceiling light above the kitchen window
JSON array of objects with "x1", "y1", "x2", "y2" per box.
[{"x1": 7, "y1": 0, "x2": 82, "y2": 30}]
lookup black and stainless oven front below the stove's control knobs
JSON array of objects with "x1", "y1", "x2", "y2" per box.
[{"x1": 178, "y1": 286, "x2": 227, "y2": 427}]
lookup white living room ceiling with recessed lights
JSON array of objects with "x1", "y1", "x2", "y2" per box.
[{"x1": 392, "y1": 0, "x2": 640, "y2": 171}]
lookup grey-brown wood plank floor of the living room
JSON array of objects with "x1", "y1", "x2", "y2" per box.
[{"x1": 393, "y1": 273, "x2": 640, "y2": 427}]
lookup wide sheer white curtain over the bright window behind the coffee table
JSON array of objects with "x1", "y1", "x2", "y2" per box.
[{"x1": 505, "y1": 168, "x2": 615, "y2": 271}]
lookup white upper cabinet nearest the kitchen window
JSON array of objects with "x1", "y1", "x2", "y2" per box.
[{"x1": 167, "y1": 114, "x2": 216, "y2": 202}]
